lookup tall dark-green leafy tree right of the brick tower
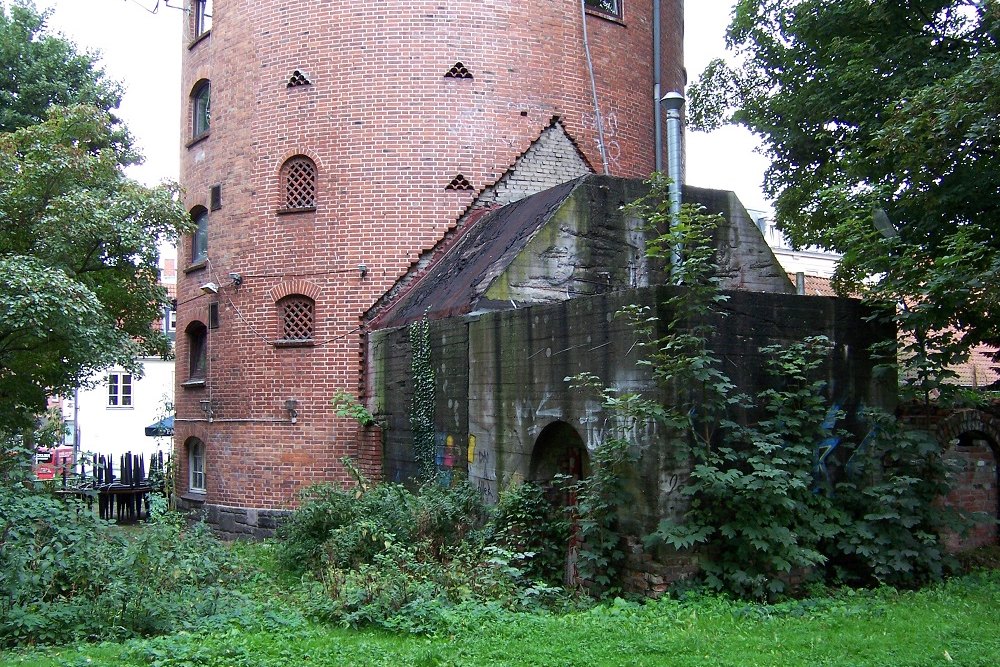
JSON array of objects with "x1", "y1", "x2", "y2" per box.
[{"x1": 691, "y1": 0, "x2": 1000, "y2": 396}]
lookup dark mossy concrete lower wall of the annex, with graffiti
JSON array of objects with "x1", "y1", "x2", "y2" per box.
[{"x1": 370, "y1": 287, "x2": 893, "y2": 530}]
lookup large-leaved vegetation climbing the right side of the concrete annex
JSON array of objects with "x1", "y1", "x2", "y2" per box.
[{"x1": 568, "y1": 179, "x2": 964, "y2": 599}]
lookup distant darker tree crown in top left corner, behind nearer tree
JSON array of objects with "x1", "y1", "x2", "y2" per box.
[{"x1": 0, "y1": 0, "x2": 121, "y2": 132}]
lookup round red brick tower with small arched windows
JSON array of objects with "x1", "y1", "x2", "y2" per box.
[{"x1": 175, "y1": 0, "x2": 684, "y2": 533}]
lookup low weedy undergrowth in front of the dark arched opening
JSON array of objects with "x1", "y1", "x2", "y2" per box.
[{"x1": 278, "y1": 464, "x2": 584, "y2": 633}]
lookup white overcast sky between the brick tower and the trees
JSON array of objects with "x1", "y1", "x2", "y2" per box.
[{"x1": 23, "y1": 0, "x2": 770, "y2": 210}]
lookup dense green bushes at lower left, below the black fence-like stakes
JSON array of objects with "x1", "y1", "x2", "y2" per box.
[{"x1": 0, "y1": 440, "x2": 239, "y2": 646}]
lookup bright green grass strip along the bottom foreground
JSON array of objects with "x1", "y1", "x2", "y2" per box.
[{"x1": 7, "y1": 572, "x2": 1000, "y2": 667}]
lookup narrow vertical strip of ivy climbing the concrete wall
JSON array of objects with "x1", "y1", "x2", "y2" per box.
[{"x1": 409, "y1": 317, "x2": 437, "y2": 479}]
